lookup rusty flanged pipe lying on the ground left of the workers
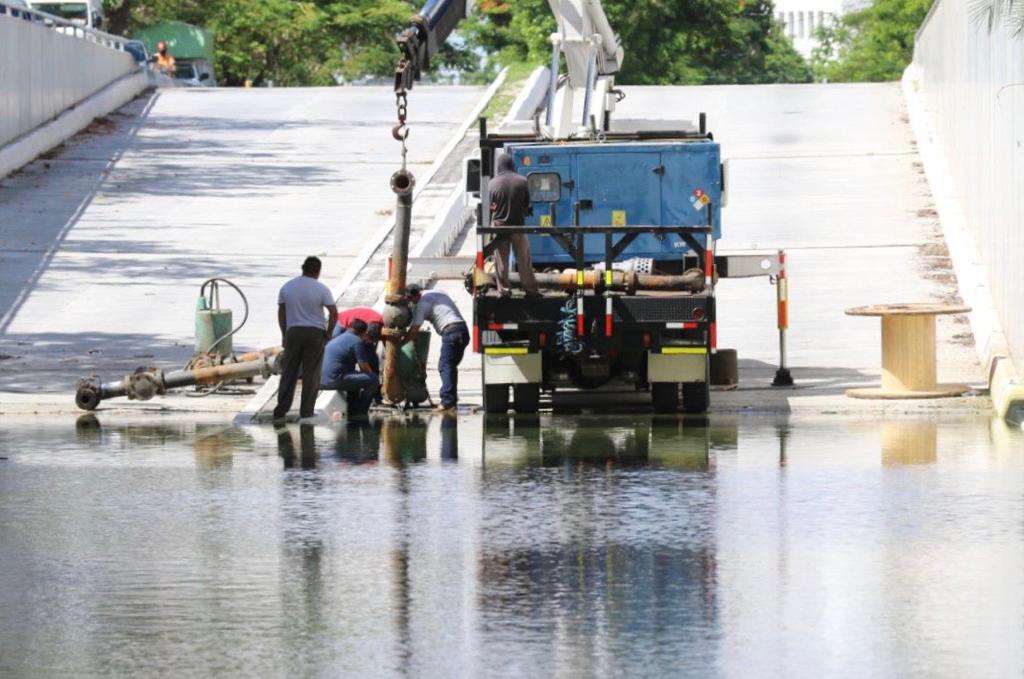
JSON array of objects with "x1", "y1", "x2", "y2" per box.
[{"x1": 75, "y1": 346, "x2": 282, "y2": 411}]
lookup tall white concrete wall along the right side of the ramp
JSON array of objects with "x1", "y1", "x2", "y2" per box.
[{"x1": 911, "y1": 0, "x2": 1024, "y2": 367}]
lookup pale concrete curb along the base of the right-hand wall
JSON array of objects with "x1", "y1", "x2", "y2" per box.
[{"x1": 900, "y1": 63, "x2": 1024, "y2": 424}]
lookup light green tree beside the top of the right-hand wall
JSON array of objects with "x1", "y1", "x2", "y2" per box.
[{"x1": 811, "y1": 0, "x2": 933, "y2": 82}]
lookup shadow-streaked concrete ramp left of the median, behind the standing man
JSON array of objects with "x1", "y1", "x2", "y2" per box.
[{"x1": 0, "y1": 87, "x2": 482, "y2": 392}]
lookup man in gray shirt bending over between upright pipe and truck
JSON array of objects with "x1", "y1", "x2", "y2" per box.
[{"x1": 406, "y1": 285, "x2": 469, "y2": 415}]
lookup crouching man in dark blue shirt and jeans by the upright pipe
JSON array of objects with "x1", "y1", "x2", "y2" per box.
[{"x1": 321, "y1": 320, "x2": 380, "y2": 416}]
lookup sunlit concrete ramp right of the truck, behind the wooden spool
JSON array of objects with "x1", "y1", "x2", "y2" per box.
[{"x1": 423, "y1": 83, "x2": 987, "y2": 412}]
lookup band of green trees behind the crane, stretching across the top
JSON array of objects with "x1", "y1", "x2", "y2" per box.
[{"x1": 105, "y1": 0, "x2": 810, "y2": 85}]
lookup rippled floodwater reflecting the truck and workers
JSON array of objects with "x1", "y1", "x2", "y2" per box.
[{"x1": 0, "y1": 415, "x2": 1024, "y2": 677}]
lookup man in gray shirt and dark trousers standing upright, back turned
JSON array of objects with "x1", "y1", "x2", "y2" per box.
[{"x1": 273, "y1": 257, "x2": 338, "y2": 420}]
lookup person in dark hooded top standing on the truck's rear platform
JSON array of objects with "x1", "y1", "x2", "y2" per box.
[{"x1": 487, "y1": 154, "x2": 540, "y2": 297}]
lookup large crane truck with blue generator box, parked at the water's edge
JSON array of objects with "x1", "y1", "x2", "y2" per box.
[{"x1": 395, "y1": 0, "x2": 783, "y2": 414}]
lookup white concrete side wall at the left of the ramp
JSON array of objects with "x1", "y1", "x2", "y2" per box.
[{"x1": 0, "y1": 9, "x2": 137, "y2": 147}]
